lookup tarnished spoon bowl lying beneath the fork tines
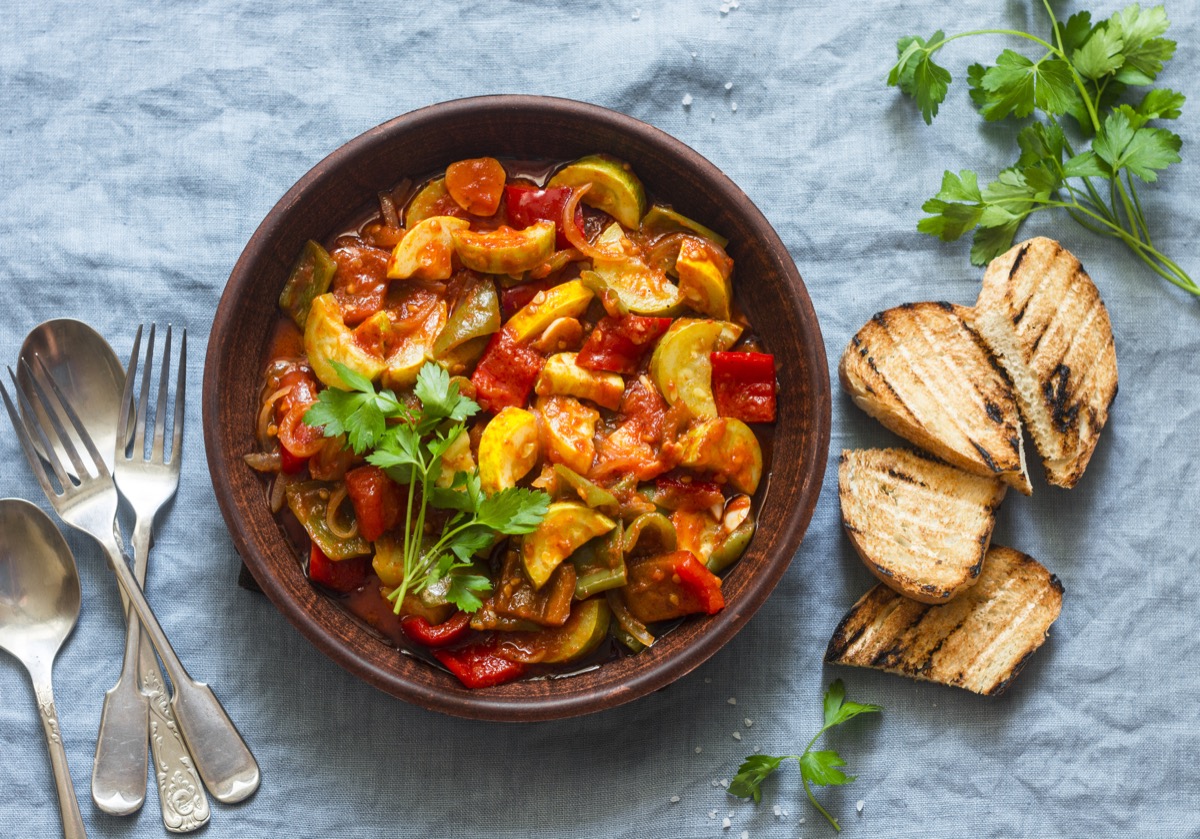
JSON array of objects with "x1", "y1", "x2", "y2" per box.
[{"x1": 17, "y1": 318, "x2": 125, "y2": 472}]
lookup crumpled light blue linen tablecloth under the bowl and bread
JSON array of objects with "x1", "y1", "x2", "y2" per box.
[{"x1": 0, "y1": 0, "x2": 1200, "y2": 839}]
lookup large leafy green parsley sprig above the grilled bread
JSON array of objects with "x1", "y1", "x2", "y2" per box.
[{"x1": 888, "y1": 0, "x2": 1200, "y2": 295}]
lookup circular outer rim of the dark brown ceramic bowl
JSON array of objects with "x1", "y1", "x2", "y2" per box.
[{"x1": 202, "y1": 95, "x2": 832, "y2": 721}]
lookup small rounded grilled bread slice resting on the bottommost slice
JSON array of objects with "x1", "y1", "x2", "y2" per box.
[{"x1": 838, "y1": 449, "x2": 1008, "y2": 603}]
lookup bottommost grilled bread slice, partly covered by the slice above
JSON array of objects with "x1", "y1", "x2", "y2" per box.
[{"x1": 826, "y1": 545, "x2": 1062, "y2": 695}]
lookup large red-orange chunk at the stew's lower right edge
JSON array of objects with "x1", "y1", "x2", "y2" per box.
[{"x1": 623, "y1": 551, "x2": 725, "y2": 623}]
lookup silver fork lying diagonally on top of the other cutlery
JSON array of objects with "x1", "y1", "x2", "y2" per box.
[{"x1": 0, "y1": 358, "x2": 260, "y2": 802}]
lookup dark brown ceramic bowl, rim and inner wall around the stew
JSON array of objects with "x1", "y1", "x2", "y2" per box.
[{"x1": 204, "y1": 96, "x2": 829, "y2": 720}]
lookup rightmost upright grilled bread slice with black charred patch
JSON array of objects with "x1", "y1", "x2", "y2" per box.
[{"x1": 976, "y1": 238, "x2": 1117, "y2": 489}]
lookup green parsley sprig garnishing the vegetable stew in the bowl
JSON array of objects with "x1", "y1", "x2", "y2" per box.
[{"x1": 304, "y1": 361, "x2": 550, "y2": 613}]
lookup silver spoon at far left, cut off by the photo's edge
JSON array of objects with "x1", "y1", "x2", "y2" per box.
[{"x1": 0, "y1": 498, "x2": 86, "y2": 839}]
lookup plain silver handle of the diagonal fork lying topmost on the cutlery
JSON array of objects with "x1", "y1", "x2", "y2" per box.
[{"x1": 94, "y1": 539, "x2": 262, "y2": 804}]
